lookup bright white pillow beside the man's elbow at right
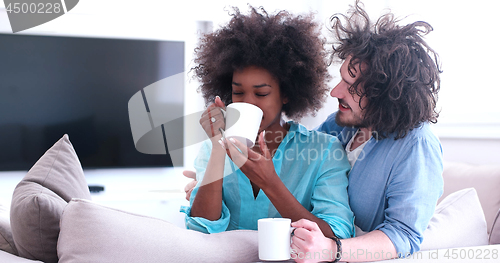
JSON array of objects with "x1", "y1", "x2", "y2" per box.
[{"x1": 420, "y1": 188, "x2": 488, "y2": 250}]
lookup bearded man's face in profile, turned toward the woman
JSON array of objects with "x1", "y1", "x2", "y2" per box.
[{"x1": 330, "y1": 56, "x2": 367, "y2": 128}]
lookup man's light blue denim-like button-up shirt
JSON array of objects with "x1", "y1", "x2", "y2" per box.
[{"x1": 316, "y1": 113, "x2": 443, "y2": 255}]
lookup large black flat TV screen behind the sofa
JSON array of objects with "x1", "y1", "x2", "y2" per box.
[{"x1": 0, "y1": 34, "x2": 184, "y2": 171}]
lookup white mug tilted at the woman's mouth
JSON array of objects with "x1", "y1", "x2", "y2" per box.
[{"x1": 223, "y1": 102, "x2": 263, "y2": 148}]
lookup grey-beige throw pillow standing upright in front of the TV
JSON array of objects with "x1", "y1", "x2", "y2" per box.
[{"x1": 10, "y1": 135, "x2": 90, "y2": 263}]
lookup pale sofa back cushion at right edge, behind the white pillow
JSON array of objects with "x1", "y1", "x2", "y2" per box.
[{"x1": 440, "y1": 162, "x2": 500, "y2": 233}]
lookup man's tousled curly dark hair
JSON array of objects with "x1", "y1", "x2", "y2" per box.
[{"x1": 330, "y1": 0, "x2": 442, "y2": 139}]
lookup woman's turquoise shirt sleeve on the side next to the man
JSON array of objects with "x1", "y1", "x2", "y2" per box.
[{"x1": 311, "y1": 137, "x2": 354, "y2": 238}]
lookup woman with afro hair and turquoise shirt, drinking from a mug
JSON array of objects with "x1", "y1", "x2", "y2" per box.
[{"x1": 182, "y1": 7, "x2": 354, "y2": 241}]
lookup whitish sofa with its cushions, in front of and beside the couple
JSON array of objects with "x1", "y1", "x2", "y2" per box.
[{"x1": 0, "y1": 135, "x2": 500, "y2": 263}]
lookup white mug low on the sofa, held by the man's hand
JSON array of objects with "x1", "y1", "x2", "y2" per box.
[{"x1": 257, "y1": 218, "x2": 295, "y2": 261}]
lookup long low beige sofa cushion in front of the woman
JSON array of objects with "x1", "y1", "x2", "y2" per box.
[{"x1": 57, "y1": 199, "x2": 259, "y2": 263}]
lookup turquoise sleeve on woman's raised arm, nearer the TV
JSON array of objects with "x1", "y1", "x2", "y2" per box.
[{"x1": 180, "y1": 142, "x2": 230, "y2": 234}]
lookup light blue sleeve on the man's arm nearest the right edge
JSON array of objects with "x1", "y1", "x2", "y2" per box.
[{"x1": 375, "y1": 138, "x2": 443, "y2": 257}]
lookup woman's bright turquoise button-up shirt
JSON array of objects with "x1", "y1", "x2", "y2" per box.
[{"x1": 181, "y1": 122, "x2": 354, "y2": 238}]
